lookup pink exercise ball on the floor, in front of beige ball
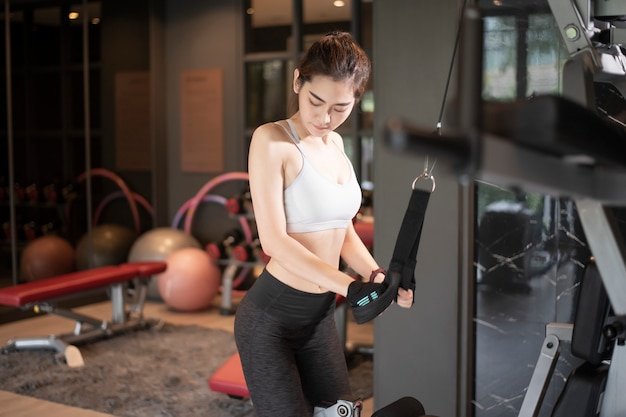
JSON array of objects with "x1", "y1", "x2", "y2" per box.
[{"x1": 157, "y1": 248, "x2": 221, "y2": 311}]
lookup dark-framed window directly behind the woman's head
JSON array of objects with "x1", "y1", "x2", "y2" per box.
[{"x1": 244, "y1": 0, "x2": 374, "y2": 183}]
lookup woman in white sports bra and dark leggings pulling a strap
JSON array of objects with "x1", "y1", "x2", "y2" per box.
[{"x1": 235, "y1": 32, "x2": 413, "y2": 417}]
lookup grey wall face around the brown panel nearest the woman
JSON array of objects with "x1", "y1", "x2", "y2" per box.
[{"x1": 164, "y1": 0, "x2": 247, "y2": 240}]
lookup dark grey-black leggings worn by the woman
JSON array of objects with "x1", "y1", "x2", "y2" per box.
[{"x1": 235, "y1": 271, "x2": 351, "y2": 417}]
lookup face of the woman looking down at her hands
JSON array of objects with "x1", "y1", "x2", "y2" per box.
[{"x1": 294, "y1": 70, "x2": 356, "y2": 137}]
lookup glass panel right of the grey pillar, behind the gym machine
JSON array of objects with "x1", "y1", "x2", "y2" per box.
[{"x1": 472, "y1": 4, "x2": 588, "y2": 417}]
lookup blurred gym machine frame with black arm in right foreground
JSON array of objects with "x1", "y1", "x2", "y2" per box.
[{"x1": 386, "y1": 0, "x2": 626, "y2": 417}]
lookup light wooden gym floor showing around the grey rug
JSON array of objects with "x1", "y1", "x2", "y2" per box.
[{"x1": 0, "y1": 297, "x2": 374, "y2": 417}]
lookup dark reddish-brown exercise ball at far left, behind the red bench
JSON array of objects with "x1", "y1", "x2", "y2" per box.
[{"x1": 20, "y1": 235, "x2": 75, "y2": 281}]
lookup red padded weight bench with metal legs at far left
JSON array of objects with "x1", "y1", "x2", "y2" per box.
[{"x1": 0, "y1": 262, "x2": 167, "y2": 367}]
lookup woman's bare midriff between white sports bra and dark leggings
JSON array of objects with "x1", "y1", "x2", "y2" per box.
[{"x1": 266, "y1": 229, "x2": 346, "y2": 293}]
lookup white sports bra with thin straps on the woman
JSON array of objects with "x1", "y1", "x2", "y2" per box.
[{"x1": 276, "y1": 119, "x2": 362, "y2": 233}]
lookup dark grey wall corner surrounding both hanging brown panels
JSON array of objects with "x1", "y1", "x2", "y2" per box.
[{"x1": 102, "y1": 0, "x2": 247, "y2": 240}]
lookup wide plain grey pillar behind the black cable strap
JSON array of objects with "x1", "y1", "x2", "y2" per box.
[{"x1": 373, "y1": 0, "x2": 465, "y2": 417}]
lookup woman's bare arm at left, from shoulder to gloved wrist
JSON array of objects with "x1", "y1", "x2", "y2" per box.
[{"x1": 248, "y1": 124, "x2": 352, "y2": 296}]
